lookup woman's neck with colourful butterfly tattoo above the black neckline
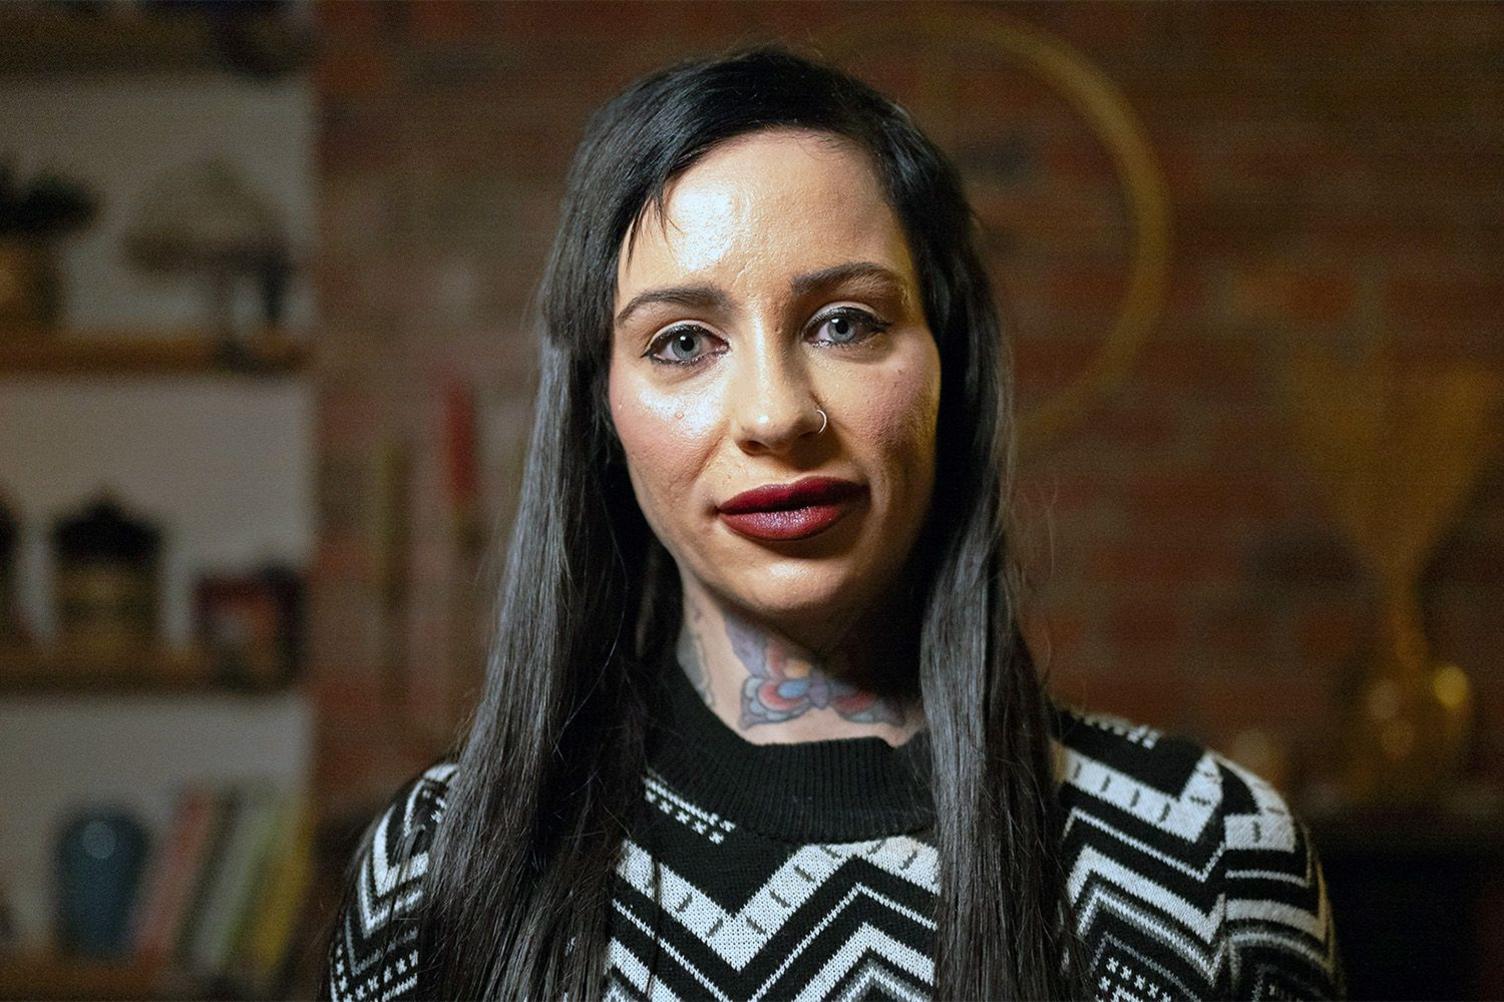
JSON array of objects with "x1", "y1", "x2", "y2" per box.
[{"x1": 677, "y1": 581, "x2": 923, "y2": 746}]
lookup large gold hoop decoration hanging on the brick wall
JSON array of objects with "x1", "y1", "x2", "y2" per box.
[{"x1": 820, "y1": 12, "x2": 1170, "y2": 456}]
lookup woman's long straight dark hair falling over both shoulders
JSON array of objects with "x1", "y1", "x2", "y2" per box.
[{"x1": 423, "y1": 48, "x2": 1089, "y2": 999}]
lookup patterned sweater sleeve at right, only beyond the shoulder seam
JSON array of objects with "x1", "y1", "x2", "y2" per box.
[{"x1": 1218, "y1": 757, "x2": 1346, "y2": 999}]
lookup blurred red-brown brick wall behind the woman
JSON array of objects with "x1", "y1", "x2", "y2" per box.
[{"x1": 313, "y1": 0, "x2": 1504, "y2": 811}]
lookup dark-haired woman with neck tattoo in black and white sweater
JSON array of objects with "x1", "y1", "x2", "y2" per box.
[{"x1": 328, "y1": 48, "x2": 1340, "y2": 999}]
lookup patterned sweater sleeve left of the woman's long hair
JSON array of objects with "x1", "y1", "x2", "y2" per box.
[{"x1": 320, "y1": 766, "x2": 454, "y2": 1002}]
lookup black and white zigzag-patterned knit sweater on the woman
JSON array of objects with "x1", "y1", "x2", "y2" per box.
[{"x1": 326, "y1": 658, "x2": 1343, "y2": 1002}]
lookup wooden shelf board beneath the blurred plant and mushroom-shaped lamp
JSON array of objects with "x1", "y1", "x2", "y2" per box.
[{"x1": 0, "y1": 331, "x2": 308, "y2": 376}]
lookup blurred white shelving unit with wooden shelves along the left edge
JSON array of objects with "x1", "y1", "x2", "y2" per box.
[{"x1": 0, "y1": 0, "x2": 323, "y2": 999}]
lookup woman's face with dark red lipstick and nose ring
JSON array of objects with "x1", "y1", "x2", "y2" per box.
[{"x1": 609, "y1": 129, "x2": 940, "y2": 639}]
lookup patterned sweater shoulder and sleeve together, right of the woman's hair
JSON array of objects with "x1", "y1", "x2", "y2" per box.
[{"x1": 1056, "y1": 709, "x2": 1343, "y2": 997}]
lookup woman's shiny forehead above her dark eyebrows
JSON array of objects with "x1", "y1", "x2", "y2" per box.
[{"x1": 617, "y1": 129, "x2": 913, "y2": 304}]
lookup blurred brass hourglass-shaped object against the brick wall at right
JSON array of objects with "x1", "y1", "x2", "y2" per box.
[{"x1": 1286, "y1": 346, "x2": 1504, "y2": 803}]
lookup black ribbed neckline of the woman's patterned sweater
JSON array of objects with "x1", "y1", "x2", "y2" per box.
[{"x1": 648, "y1": 648, "x2": 934, "y2": 843}]
